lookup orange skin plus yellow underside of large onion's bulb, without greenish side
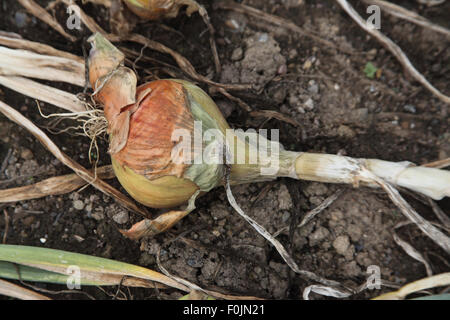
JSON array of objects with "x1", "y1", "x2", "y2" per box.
[{"x1": 110, "y1": 80, "x2": 198, "y2": 208}]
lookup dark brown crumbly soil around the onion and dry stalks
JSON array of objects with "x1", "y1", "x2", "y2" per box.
[{"x1": 0, "y1": 0, "x2": 450, "y2": 299}]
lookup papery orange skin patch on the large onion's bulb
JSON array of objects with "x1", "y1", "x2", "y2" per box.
[{"x1": 111, "y1": 80, "x2": 194, "y2": 180}]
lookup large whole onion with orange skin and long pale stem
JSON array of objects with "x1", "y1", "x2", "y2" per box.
[{"x1": 89, "y1": 34, "x2": 450, "y2": 237}]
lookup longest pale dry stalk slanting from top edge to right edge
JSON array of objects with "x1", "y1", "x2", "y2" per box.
[{"x1": 336, "y1": 0, "x2": 450, "y2": 104}]
